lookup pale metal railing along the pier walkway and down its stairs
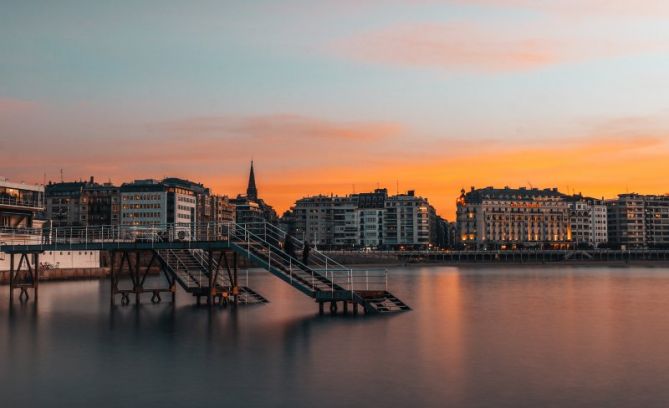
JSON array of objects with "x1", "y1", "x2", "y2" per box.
[{"x1": 0, "y1": 223, "x2": 388, "y2": 291}]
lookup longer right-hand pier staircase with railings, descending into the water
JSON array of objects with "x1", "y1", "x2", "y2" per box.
[{"x1": 227, "y1": 223, "x2": 411, "y2": 313}]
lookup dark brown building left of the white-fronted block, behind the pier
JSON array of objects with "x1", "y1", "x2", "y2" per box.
[{"x1": 45, "y1": 177, "x2": 121, "y2": 227}]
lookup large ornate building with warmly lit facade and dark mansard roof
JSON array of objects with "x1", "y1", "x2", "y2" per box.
[{"x1": 457, "y1": 187, "x2": 572, "y2": 249}]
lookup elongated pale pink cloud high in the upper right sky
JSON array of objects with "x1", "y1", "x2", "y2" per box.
[{"x1": 333, "y1": 22, "x2": 667, "y2": 72}]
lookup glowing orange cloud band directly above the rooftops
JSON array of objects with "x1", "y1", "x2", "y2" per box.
[{"x1": 0, "y1": 106, "x2": 669, "y2": 219}]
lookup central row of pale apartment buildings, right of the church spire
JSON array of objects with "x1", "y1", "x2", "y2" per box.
[{"x1": 289, "y1": 189, "x2": 437, "y2": 249}]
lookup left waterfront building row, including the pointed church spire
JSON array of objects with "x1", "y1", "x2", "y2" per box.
[{"x1": 44, "y1": 164, "x2": 277, "y2": 234}]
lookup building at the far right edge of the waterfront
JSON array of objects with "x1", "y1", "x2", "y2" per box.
[{"x1": 606, "y1": 194, "x2": 669, "y2": 248}]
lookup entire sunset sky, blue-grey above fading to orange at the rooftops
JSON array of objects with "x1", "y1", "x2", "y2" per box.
[{"x1": 0, "y1": 0, "x2": 669, "y2": 220}]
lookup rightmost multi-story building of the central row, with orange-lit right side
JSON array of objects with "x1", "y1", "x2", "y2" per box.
[{"x1": 383, "y1": 190, "x2": 437, "y2": 248}]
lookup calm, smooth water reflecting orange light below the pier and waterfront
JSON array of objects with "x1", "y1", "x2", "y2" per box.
[{"x1": 0, "y1": 267, "x2": 669, "y2": 407}]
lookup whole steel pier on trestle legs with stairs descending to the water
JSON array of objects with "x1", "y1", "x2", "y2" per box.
[{"x1": 0, "y1": 223, "x2": 410, "y2": 314}]
